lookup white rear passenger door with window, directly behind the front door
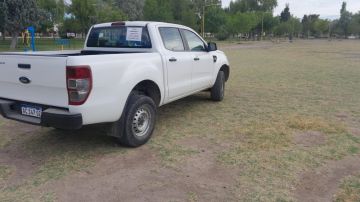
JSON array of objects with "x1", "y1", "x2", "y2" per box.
[{"x1": 159, "y1": 27, "x2": 193, "y2": 100}]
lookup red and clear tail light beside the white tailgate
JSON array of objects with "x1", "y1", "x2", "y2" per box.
[{"x1": 66, "y1": 66, "x2": 92, "y2": 105}]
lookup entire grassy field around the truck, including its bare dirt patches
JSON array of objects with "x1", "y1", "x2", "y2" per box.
[{"x1": 0, "y1": 41, "x2": 360, "y2": 201}]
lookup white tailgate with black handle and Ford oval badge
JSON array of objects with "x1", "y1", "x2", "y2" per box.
[{"x1": 0, "y1": 54, "x2": 68, "y2": 107}]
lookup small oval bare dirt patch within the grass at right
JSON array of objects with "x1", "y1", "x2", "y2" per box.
[{"x1": 294, "y1": 131, "x2": 326, "y2": 147}]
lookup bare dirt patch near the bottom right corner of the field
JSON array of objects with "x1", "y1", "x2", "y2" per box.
[{"x1": 295, "y1": 157, "x2": 360, "y2": 202}]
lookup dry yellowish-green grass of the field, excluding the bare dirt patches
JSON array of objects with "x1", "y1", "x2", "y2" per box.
[{"x1": 0, "y1": 41, "x2": 360, "y2": 201}]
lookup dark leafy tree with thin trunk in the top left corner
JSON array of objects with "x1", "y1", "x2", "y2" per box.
[{"x1": 3, "y1": 0, "x2": 39, "y2": 50}]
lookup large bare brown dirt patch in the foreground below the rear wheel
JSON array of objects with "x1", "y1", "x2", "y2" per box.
[{"x1": 42, "y1": 137, "x2": 236, "y2": 201}]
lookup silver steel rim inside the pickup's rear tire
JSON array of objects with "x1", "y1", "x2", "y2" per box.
[{"x1": 132, "y1": 106, "x2": 151, "y2": 137}]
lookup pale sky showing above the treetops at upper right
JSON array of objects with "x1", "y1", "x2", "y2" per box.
[{"x1": 222, "y1": 0, "x2": 360, "y2": 19}]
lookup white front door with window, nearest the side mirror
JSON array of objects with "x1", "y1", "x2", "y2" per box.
[{"x1": 182, "y1": 29, "x2": 215, "y2": 91}]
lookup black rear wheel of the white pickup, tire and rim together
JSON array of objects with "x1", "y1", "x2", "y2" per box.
[{"x1": 114, "y1": 93, "x2": 156, "y2": 147}]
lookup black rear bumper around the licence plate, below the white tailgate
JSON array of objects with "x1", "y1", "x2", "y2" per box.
[{"x1": 0, "y1": 99, "x2": 83, "y2": 130}]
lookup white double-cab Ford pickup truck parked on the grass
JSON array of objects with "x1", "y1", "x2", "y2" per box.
[{"x1": 0, "y1": 22, "x2": 230, "y2": 147}]
